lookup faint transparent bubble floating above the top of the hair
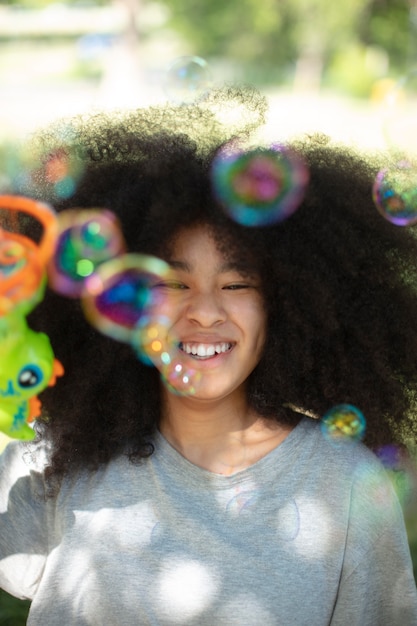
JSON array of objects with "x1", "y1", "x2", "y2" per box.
[{"x1": 164, "y1": 56, "x2": 212, "y2": 104}]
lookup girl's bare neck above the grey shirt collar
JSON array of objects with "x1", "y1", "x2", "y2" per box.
[{"x1": 160, "y1": 392, "x2": 292, "y2": 475}]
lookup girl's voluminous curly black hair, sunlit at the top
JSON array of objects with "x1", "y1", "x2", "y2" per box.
[{"x1": 22, "y1": 83, "x2": 417, "y2": 475}]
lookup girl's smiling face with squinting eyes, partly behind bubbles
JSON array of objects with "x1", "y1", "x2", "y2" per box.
[{"x1": 150, "y1": 226, "x2": 266, "y2": 401}]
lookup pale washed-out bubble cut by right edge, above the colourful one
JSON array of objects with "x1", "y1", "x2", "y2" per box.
[{"x1": 383, "y1": 69, "x2": 417, "y2": 155}]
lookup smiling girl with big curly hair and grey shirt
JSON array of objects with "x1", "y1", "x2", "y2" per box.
[{"x1": 0, "y1": 90, "x2": 417, "y2": 626}]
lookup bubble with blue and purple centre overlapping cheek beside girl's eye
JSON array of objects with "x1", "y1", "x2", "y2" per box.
[{"x1": 81, "y1": 254, "x2": 171, "y2": 345}]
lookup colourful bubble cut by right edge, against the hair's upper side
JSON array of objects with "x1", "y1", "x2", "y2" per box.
[{"x1": 372, "y1": 161, "x2": 417, "y2": 226}]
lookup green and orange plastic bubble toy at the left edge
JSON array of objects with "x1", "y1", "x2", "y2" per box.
[{"x1": 0, "y1": 195, "x2": 64, "y2": 440}]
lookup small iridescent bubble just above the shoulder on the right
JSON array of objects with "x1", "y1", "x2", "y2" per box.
[{"x1": 320, "y1": 404, "x2": 366, "y2": 441}]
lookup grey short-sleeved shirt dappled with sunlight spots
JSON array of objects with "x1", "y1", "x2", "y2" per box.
[{"x1": 0, "y1": 418, "x2": 417, "y2": 626}]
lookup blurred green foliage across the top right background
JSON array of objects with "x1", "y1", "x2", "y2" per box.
[{"x1": 0, "y1": 0, "x2": 417, "y2": 97}]
